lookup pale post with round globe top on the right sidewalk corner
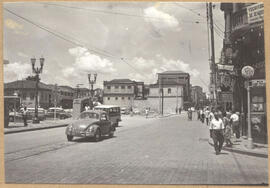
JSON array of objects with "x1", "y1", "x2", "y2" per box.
[{"x1": 241, "y1": 66, "x2": 254, "y2": 149}]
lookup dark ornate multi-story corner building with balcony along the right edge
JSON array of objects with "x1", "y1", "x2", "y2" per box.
[{"x1": 218, "y1": 3, "x2": 267, "y2": 142}]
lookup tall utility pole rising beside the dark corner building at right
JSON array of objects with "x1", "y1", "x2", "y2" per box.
[{"x1": 208, "y1": 3, "x2": 217, "y2": 104}]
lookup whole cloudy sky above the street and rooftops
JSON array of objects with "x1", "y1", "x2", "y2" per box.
[{"x1": 4, "y1": 2, "x2": 224, "y2": 91}]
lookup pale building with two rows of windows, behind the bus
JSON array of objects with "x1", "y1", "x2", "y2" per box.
[{"x1": 103, "y1": 79, "x2": 137, "y2": 108}]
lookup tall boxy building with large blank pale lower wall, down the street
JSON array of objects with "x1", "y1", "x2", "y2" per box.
[{"x1": 147, "y1": 71, "x2": 190, "y2": 113}]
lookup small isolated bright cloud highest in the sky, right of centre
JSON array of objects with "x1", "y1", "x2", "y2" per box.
[{"x1": 144, "y1": 7, "x2": 179, "y2": 29}]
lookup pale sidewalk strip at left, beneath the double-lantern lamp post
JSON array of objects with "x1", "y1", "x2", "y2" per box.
[{"x1": 4, "y1": 118, "x2": 72, "y2": 134}]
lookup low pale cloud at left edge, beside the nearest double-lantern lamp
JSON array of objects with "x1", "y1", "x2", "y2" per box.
[{"x1": 4, "y1": 62, "x2": 32, "y2": 82}]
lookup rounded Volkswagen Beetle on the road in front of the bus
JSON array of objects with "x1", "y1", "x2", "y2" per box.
[{"x1": 66, "y1": 110, "x2": 115, "y2": 142}]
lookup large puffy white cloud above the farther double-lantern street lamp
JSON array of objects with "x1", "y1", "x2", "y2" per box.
[{"x1": 63, "y1": 47, "x2": 116, "y2": 77}]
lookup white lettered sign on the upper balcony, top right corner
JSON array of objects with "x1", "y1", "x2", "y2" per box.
[{"x1": 247, "y1": 3, "x2": 264, "y2": 24}]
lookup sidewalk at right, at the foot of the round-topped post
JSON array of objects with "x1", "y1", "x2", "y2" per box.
[{"x1": 208, "y1": 129, "x2": 268, "y2": 158}]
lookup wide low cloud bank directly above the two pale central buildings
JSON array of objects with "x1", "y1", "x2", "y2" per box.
[{"x1": 129, "y1": 54, "x2": 200, "y2": 83}]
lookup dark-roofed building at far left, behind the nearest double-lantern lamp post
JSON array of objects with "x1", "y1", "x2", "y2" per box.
[{"x1": 4, "y1": 80, "x2": 53, "y2": 108}]
